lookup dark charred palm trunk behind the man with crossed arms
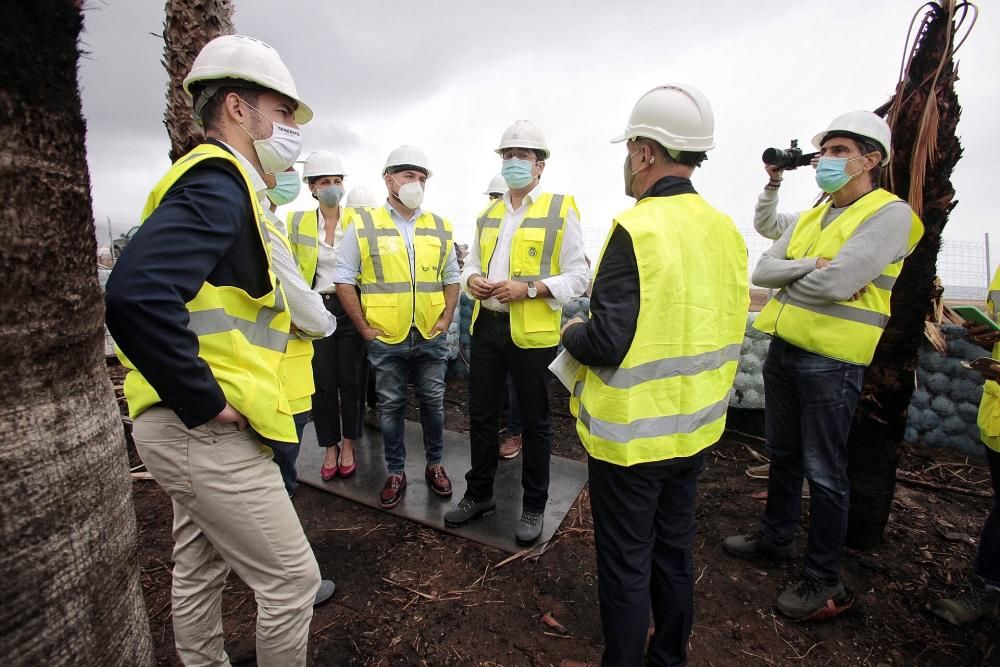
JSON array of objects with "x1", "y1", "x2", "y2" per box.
[{"x1": 847, "y1": 0, "x2": 963, "y2": 549}]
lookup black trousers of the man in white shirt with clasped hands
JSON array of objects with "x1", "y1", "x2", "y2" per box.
[{"x1": 465, "y1": 308, "x2": 556, "y2": 512}]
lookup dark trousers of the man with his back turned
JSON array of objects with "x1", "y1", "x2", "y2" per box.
[{"x1": 587, "y1": 454, "x2": 704, "y2": 667}]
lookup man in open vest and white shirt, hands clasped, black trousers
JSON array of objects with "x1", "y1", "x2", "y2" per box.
[{"x1": 444, "y1": 120, "x2": 588, "y2": 545}]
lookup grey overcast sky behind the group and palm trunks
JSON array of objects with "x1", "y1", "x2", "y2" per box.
[{"x1": 80, "y1": 0, "x2": 1000, "y2": 290}]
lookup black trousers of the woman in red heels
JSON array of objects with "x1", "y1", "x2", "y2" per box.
[{"x1": 312, "y1": 294, "x2": 368, "y2": 447}]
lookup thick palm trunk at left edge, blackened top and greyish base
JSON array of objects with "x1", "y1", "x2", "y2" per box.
[{"x1": 0, "y1": 0, "x2": 153, "y2": 667}]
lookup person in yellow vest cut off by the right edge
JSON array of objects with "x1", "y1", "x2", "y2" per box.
[{"x1": 933, "y1": 269, "x2": 1000, "y2": 625}]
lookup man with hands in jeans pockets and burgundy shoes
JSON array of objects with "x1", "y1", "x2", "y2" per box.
[{"x1": 334, "y1": 146, "x2": 459, "y2": 509}]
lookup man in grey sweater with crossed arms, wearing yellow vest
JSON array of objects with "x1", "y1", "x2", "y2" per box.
[{"x1": 723, "y1": 111, "x2": 923, "y2": 620}]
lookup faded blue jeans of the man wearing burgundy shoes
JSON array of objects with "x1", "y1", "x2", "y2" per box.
[{"x1": 368, "y1": 329, "x2": 448, "y2": 475}]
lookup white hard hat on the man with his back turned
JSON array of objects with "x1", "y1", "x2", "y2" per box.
[{"x1": 611, "y1": 83, "x2": 715, "y2": 153}]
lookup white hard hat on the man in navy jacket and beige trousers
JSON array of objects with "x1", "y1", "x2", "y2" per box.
[{"x1": 184, "y1": 35, "x2": 312, "y2": 125}]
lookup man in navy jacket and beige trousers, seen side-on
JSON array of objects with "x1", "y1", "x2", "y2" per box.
[{"x1": 105, "y1": 35, "x2": 328, "y2": 665}]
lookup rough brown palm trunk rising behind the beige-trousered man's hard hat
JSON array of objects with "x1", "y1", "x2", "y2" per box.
[{"x1": 163, "y1": 0, "x2": 233, "y2": 162}]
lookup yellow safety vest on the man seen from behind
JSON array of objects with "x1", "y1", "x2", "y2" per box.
[{"x1": 570, "y1": 194, "x2": 750, "y2": 466}]
